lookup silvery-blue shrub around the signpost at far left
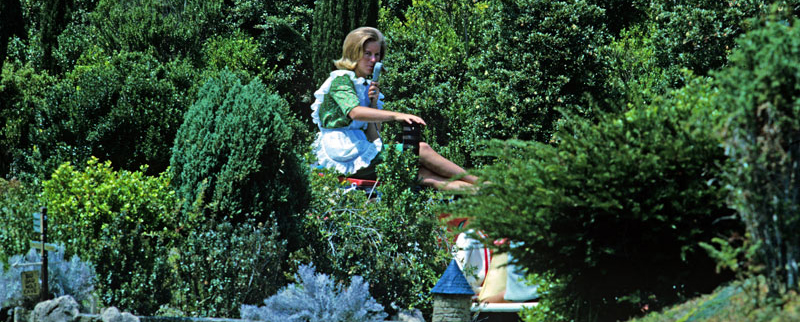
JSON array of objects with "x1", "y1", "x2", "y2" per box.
[{"x1": 0, "y1": 245, "x2": 95, "y2": 308}]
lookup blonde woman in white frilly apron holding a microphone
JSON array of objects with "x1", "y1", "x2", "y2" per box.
[{"x1": 311, "y1": 27, "x2": 477, "y2": 190}]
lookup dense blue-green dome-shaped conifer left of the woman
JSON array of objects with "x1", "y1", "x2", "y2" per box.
[{"x1": 170, "y1": 71, "x2": 309, "y2": 245}]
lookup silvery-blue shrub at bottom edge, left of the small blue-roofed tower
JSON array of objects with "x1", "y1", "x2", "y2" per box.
[{"x1": 241, "y1": 266, "x2": 386, "y2": 322}]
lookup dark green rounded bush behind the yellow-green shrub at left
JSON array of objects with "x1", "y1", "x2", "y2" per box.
[{"x1": 26, "y1": 49, "x2": 196, "y2": 175}]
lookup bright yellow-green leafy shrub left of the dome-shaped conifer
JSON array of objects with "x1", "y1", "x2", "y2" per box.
[{"x1": 42, "y1": 158, "x2": 181, "y2": 314}]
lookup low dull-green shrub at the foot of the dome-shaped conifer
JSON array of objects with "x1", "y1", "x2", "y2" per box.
[{"x1": 166, "y1": 219, "x2": 286, "y2": 318}]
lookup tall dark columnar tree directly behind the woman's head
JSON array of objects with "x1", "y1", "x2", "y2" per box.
[{"x1": 311, "y1": 0, "x2": 379, "y2": 85}]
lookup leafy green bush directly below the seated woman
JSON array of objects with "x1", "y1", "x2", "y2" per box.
[{"x1": 300, "y1": 149, "x2": 450, "y2": 315}]
